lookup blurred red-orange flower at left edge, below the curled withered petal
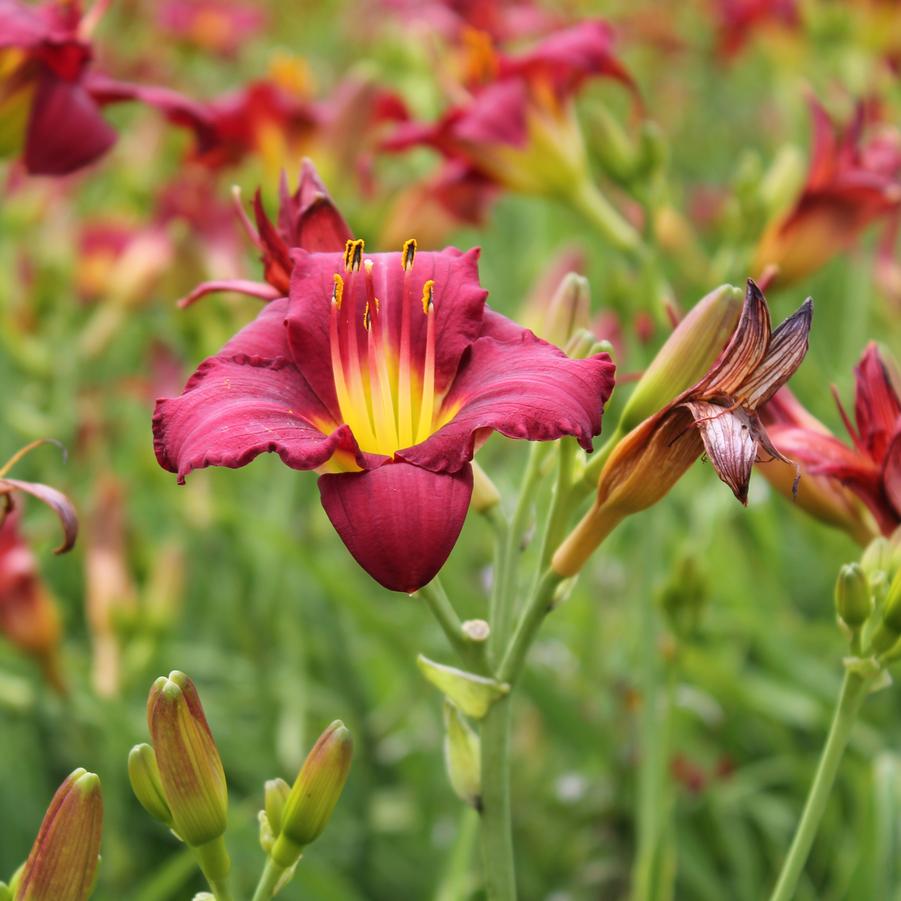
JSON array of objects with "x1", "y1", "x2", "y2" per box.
[{"x1": 0, "y1": 511, "x2": 63, "y2": 690}]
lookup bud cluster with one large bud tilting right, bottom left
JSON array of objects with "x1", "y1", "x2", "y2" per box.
[{"x1": 259, "y1": 720, "x2": 353, "y2": 890}]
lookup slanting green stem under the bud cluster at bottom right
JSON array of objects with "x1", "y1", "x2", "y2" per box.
[{"x1": 770, "y1": 669, "x2": 876, "y2": 901}]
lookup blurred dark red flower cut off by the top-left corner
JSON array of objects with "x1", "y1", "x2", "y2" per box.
[{"x1": 0, "y1": 0, "x2": 214, "y2": 175}]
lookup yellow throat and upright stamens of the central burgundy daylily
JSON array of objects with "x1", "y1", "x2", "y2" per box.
[{"x1": 329, "y1": 239, "x2": 445, "y2": 456}]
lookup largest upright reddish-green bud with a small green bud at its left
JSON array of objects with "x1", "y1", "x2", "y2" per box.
[{"x1": 147, "y1": 670, "x2": 228, "y2": 847}]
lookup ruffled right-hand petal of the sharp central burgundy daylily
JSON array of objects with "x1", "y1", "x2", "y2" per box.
[{"x1": 396, "y1": 330, "x2": 614, "y2": 472}]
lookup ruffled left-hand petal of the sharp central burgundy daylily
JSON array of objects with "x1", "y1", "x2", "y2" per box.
[{"x1": 153, "y1": 355, "x2": 357, "y2": 482}]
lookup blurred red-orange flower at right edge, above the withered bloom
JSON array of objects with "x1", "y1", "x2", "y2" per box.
[{"x1": 754, "y1": 98, "x2": 901, "y2": 284}]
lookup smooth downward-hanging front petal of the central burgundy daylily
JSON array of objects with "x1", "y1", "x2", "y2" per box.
[{"x1": 319, "y1": 463, "x2": 472, "y2": 594}]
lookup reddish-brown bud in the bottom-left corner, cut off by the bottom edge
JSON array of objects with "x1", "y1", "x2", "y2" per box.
[{"x1": 15, "y1": 767, "x2": 103, "y2": 901}]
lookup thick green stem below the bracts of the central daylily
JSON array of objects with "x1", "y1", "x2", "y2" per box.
[{"x1": 481, "y1": 698, "x2": 516, "y2": 901}]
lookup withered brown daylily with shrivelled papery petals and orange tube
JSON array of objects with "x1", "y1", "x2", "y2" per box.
[{"x1": 552, "y1": 279, "x2": 813, "y2": 576}]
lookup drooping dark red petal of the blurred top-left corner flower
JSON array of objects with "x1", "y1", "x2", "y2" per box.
[{"x1": 24, "y1": 73, "x2": 116, "y2": 175}]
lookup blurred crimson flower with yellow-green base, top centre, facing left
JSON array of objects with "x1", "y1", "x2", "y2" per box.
[{"x1": 385, "y1": 20, "x2": 634, "y2": 196}]
